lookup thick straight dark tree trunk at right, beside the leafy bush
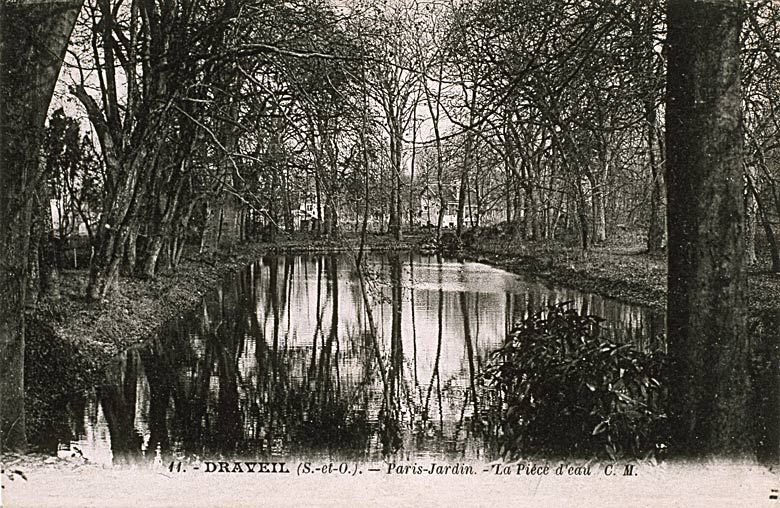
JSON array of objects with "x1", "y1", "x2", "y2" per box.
[{"x1": 666, "y1": 0, "x2": 752, "y2": 457}]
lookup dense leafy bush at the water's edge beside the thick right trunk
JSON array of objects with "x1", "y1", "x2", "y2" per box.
[{"x1": 485, "y1": 303, "x2": 666, "y2": 459}]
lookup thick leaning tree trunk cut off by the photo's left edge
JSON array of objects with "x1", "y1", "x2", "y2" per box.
[{"x1": 0, "y1": 1, "x2": 81, "y2": 450}]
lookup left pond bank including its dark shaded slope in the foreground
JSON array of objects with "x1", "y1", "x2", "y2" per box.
[{"x1": 25, "y1": 236, "x2": 411, "y2": 453}]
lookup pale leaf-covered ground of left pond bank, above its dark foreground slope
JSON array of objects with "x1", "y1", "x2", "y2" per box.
[{"x1": 28, "y1": 237, "x2": 412, "y2": 358}]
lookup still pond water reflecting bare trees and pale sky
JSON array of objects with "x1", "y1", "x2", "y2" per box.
[{"x1": 41, "y1": 254, "x2": 664, "y2": 463}]
